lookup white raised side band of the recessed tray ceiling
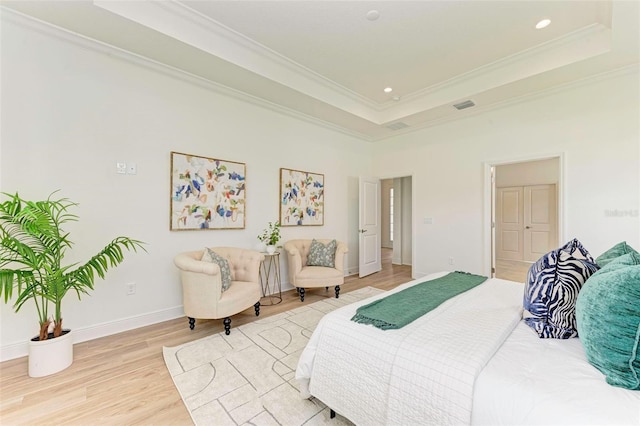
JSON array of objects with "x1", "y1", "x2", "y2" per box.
[{"x1": 94, "y1": 0, "x2": 611, "y2": 125}]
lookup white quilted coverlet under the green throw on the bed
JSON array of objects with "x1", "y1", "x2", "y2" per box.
[{"x1": 296, "y1": 272, "x2": 523, "y2": 425}]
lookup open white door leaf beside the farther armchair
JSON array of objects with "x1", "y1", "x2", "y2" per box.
[{"x1": 358, "y1": 178, "x2": 382, "y2": 277}]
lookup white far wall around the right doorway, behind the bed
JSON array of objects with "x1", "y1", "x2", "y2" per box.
[{"x1": 374, "y1": 68, "x2": 640, "y2": 276}]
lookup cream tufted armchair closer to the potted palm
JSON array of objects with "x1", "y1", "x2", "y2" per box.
[{"x1": 173, "y1": 247, "x2": 264, "y2": 334}]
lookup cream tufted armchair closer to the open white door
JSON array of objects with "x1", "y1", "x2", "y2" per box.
[{"x1": 284, "y1": 240, "x2": 348, "y2": 302}]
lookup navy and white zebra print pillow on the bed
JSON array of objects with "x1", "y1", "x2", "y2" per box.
[{"x1": 524, "y1": 239, "x2": 598, "y2": 339}]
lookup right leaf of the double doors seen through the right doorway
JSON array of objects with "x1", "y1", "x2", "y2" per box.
[{"x1": 523, "y1": 184, "x2": 558, "y2": 262}]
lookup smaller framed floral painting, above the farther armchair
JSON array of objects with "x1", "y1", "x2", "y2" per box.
[{"x1": 280, "y1": 168, "x2": 324, "y2": 226}]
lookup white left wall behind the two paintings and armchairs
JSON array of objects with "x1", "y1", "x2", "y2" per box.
[{"x1": 0, "y1": 15, "x2": 371, "y2": 359}]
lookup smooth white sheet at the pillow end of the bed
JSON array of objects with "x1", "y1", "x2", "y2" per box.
[{"x1": 472, "y1": 322, "x2": 640, "y2": 425}]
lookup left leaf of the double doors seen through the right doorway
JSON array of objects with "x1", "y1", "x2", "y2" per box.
[{"x1": 496, "y1": 186, "x2": 524, "y2": 260}]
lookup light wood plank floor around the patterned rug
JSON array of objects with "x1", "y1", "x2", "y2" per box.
[{"x1": 0, "y1": 249, "x2": 411, "y2": 426}]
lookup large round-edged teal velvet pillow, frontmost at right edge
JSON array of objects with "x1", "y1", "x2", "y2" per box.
[{"x1": 576, "y1": 253, "x2": 640, "y2": 390}]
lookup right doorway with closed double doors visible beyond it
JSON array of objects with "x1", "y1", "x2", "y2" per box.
[{"x1": 490, "y1": 156, "x2": 562, "y2": 282}]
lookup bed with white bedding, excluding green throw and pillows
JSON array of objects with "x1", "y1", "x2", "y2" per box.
[{"x1": 296, "y1": 272, "x2": 640, "y2": 425}]
